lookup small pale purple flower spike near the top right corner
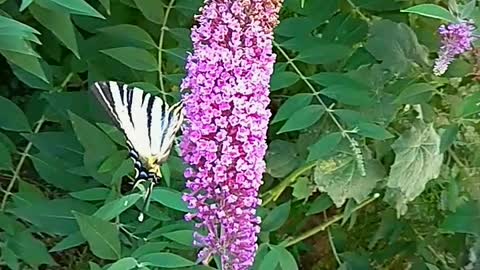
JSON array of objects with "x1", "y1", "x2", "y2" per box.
[{"x1": 433, "y1": 23, "x2": 475, "y2": 76}]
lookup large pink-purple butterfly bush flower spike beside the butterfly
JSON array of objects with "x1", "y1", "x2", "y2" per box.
[{"x1": 181, "y1": 0, "x2": 281, "y2": 270}]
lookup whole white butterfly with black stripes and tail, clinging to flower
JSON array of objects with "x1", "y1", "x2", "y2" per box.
[{"x1": 92, "y1": 81, "x2": 184, "y2": 221}]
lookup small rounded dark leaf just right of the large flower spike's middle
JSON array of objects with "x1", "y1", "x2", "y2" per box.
[{"x1": 265, "y1": 140, "x2": 300, "y2": 178}]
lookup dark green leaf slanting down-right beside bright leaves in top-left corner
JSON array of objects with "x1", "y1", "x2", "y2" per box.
[{"x1": 29, "y1": 4, "x2": 80, "y2": 59}]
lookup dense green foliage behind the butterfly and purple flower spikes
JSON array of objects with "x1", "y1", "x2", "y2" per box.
[{"x1": 0, "y1": 0, "x2": 480, "y2": 270}]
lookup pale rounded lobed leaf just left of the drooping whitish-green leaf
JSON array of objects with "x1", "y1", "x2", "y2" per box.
[{"x1": 314, "y1": 156, "x2": 384, "y2": 207}]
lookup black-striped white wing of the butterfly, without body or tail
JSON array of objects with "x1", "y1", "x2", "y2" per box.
[{"x1": 93, "y1": 82, "x2": 183, "y2": 161}]
